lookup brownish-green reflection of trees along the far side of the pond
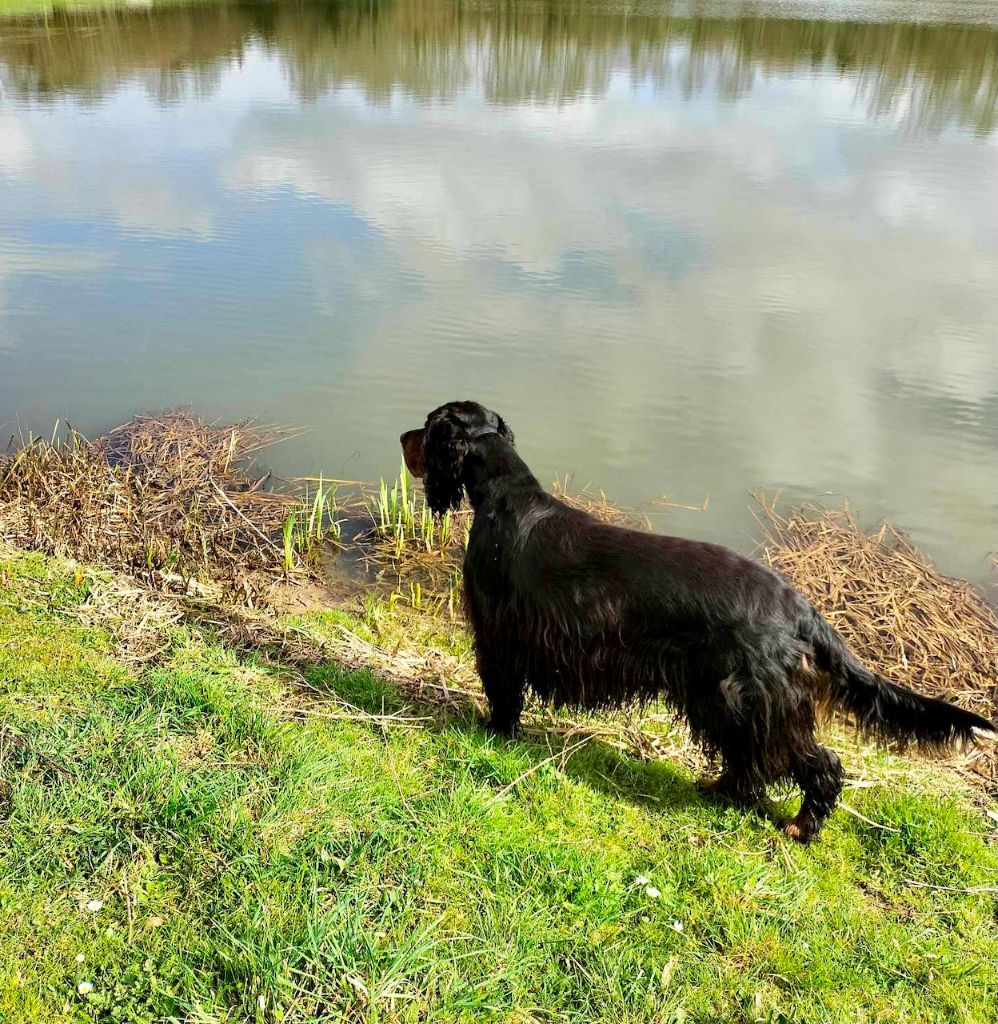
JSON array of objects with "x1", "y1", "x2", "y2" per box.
[{"x1": 0, "y1": 0, "x2": 998, "y2": 132}]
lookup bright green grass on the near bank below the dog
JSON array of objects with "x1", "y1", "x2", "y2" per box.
[{"x1": 0, "y1": 554, "x2": 998, "y2": 1024}]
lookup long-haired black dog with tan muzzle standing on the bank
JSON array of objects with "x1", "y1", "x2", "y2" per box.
[{"x1": 400, "y1": 401, "x2": 998, "y2": 842}]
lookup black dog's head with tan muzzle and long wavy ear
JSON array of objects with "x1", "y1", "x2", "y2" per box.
[{"x1": 399, "y1": 401, "x2": 513, "y2": 515}]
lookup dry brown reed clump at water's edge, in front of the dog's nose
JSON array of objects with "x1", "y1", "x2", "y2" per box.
[{"x1": 0, "y1": 412, "x2": 311, "y2": 603}]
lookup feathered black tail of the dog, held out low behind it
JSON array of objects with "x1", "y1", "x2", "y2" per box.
[{"x1": 806, "y1": 610, "x2": 998, "y2": 750}]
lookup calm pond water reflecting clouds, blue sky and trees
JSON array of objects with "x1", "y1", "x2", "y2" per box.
[{"x1": 0, "y1": 0, "x2": 998, "y2": 581}]
